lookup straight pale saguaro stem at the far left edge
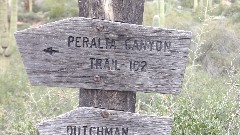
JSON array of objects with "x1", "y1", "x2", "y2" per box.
[{"x1": 0, "y1": 0, "x2": 9, "y2": 51}]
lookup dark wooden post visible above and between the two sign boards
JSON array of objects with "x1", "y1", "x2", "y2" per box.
[{"x1": 78, "y1": 0, "x2": 144, "y2": 112}]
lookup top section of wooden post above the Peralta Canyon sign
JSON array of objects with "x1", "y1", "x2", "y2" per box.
[{"x1": 78, "y1": 0, "x2": 144, "y2": 24}]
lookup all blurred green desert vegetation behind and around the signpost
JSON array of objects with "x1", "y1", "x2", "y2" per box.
[{"x1": 0, "y1": 0, "x2": 240, "y2": 135}]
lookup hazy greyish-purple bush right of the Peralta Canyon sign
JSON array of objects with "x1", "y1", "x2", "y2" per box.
[{"x1": 194, "y1": 22, "x2": 240, "y2": 75}]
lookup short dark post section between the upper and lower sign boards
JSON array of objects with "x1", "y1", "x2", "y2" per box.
[{"x1": 79, "y1": 89, "x2": 136, "y2": 112}]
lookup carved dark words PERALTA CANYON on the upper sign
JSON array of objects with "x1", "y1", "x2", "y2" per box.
[{"x1": 67, "y1": 36, "x2": 171, "y2": 52}]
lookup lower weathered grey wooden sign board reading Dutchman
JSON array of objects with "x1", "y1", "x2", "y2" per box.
[{"x1": 37, "y1": 107, "x2": 172, "y2": 135}]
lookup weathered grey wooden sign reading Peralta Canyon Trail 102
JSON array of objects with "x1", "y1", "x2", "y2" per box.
[{"x1": 15, "y1": 17, "x2": 191, "y2": 94}]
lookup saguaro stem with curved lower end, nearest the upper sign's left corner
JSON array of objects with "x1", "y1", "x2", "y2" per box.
[{"x1": 4, "y1": 0, "x2": 18, "y2": 56}]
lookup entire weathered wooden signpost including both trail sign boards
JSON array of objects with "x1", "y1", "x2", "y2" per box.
[{"x1": 15, "y1": 0, "x2": 191, "y2": 135}]
